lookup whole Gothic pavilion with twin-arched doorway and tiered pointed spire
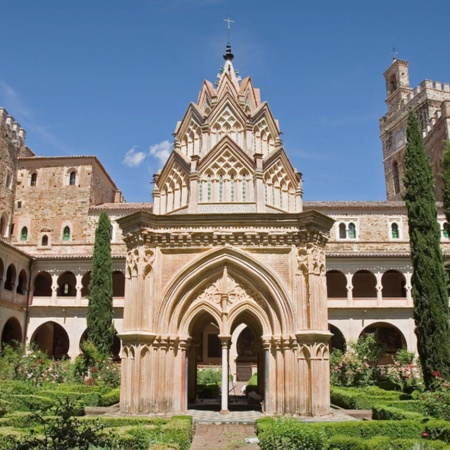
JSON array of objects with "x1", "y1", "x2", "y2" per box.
[{"x1": 118, "y1": 46, "x2": 333, "y2": 416}]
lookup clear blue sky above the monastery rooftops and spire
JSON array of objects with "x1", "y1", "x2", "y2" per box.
[{"x1": 0, "y1": 0, "x2": 450, "y2": 202}]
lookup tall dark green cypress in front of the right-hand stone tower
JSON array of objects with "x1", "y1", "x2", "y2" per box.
[{"x1": 404, "y1": 111, "x2": 450, "y2": 388}]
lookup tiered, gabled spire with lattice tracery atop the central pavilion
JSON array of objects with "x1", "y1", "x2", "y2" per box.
[{"x1": 153, "y1": 44, "x2": 303, "y2": 215}]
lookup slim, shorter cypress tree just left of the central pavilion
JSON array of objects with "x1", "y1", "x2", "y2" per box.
[{"x1": 87, "y1": 212, "x2": 114, "y2": 355}]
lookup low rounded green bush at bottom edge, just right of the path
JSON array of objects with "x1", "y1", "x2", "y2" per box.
[{"x1": 258, "y1": 418, "x2": 326, "y2": 450}]
